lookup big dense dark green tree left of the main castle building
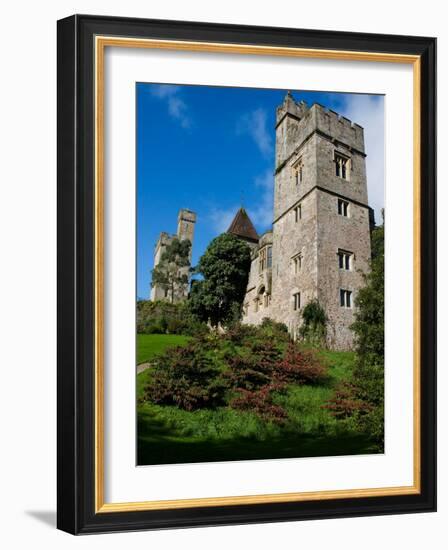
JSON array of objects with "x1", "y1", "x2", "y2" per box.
[{"x1": 190, "y1": 233, "x2": 251, "y2": 327}]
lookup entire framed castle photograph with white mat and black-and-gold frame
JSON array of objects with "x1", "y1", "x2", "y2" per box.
[{"x1": 58, "y1": 15, "x2": 436, "y2": 534}]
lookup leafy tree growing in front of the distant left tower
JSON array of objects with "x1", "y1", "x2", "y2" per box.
[{"x1": 151, "y1": 238, "x2": 191, "y2": 303}]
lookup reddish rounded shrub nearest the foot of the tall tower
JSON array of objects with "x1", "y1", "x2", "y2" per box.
[{"x1": 275, "y1": 342, "x2": 327, "y2": 384}]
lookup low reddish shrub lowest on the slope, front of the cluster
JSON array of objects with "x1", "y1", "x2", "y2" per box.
[{"x1": 230, "y1": 384, "x2": 288, "y2": 424}]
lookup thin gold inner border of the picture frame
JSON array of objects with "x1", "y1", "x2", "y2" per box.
[{"x1": 94, "y1": 36, "x2": 421, "y2": 513}]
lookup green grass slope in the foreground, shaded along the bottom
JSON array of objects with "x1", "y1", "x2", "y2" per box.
[{"x1": 137, "y1": 351, "x2": 375, "y2": 464}]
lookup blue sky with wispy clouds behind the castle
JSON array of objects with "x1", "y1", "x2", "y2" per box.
[{"x1": 136, "y1": 83, "x2": 384, "y2": 298}]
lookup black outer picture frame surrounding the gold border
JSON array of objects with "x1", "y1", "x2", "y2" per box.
[{"x1": 57, "y1": 15, "x2": 436, "y2": 534}]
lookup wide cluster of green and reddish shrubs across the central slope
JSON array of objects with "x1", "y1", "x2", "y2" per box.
[{"x1": 145, "y1": 321, "x2": 326, "y2": 422}]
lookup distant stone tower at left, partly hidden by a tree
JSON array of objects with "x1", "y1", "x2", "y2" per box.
[{"x1": 150, "y1": 208, "x2": 196, "y2": 302}]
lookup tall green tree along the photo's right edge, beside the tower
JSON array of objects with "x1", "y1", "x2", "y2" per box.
[{"x1": 351, "y1": 224, "x2": 384, "y2": 447}]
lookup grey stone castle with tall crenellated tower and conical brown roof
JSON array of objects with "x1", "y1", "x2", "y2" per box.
[{"x1": 151, "y1": 92, "x2": 373, "y2": 349}]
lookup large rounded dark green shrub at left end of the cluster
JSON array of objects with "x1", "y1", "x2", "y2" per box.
[{"x1": 145, "y1": 343, "x2": 227, "y2": 411}]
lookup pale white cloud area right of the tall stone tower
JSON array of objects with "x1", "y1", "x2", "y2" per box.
[{"x1": 338, "y1": 94, "x2": 385, "y2": 223}]
